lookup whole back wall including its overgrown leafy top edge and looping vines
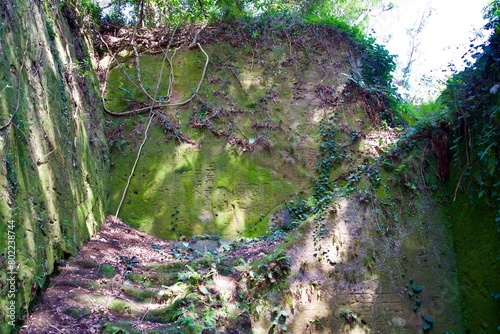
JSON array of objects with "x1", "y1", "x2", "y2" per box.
[{"x1": 102, "y1": 17, "x2": 394, "y2": 238}]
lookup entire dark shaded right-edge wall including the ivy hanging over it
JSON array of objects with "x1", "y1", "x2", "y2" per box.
[{"x1": 438, "y1": 5, "x2": 500, "y2": 333}]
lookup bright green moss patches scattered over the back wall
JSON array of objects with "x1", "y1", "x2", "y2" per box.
[{"x1": 107, "y1": 45, "x2": 322, "y2": 239}]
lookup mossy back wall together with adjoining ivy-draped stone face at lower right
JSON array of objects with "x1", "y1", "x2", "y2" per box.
[{"x1": 100, "y1": 26, "x2": 468, "y2": 333}]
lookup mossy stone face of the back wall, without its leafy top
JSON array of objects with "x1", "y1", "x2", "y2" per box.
[{"x1": 106, "y1": 37, "x2": 356, "y2": 239}]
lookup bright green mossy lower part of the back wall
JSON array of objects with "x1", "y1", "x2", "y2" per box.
[{"x1": 111, "y1": 129, "x2": 302, "y2": 239}]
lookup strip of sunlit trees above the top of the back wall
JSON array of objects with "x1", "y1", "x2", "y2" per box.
[{"x1": 99, "y1": 0, "x2": 380, "y2": 26}]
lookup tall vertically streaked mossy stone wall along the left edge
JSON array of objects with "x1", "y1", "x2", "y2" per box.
[{"x1": 0, "y1": 0, "x2": 109, "y2": 333}]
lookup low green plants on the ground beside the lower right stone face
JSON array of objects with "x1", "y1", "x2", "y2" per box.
[{"x1": 146, "y1": 250, "x2": 291, "y2": 333}]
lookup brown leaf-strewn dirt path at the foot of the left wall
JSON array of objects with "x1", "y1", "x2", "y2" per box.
[{"x1": 20, "y1": 216, "x2": 281, "y2": 334}]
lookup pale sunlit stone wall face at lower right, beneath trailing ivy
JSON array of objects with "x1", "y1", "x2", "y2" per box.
[{"x1": 285, "y1": 194, "x2": 461, "y2": 333}]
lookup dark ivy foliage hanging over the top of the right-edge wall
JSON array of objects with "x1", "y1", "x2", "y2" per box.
[{"x1": 441, "y1": 0, "x2": 500, "y2": 231}]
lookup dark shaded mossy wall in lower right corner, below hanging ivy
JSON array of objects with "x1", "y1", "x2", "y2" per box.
[{"x1": 447, "y1": 172, "x2": 500, "y2": 333}]
